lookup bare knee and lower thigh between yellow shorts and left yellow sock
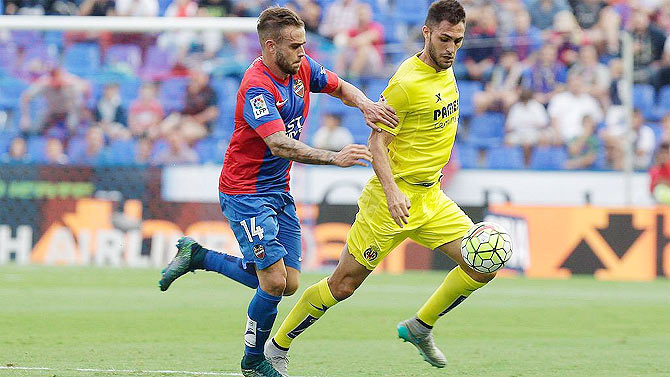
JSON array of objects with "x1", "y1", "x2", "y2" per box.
[{"x1": 328, "y1": 243, "x2": 372, "y2": 301}]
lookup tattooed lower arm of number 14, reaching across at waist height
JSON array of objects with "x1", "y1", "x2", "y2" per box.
[{"x1": 263, "y1": 132, "x2": 372, "y2": 168}]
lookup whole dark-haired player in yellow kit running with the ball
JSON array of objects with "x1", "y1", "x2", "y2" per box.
[{"x1": 265, "y1": 0, "x2": 495, "y2": 375}]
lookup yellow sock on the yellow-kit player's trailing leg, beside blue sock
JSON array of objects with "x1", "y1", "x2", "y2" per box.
[{"x1": 274, "y1": 278, "x2": 337, "y2": 349}]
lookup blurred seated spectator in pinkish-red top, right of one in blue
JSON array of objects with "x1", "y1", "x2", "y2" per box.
[{"x1": 128, "y1": 82, "x2": 165, "y2": 139}]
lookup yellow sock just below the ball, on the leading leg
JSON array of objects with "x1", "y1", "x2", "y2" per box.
[{"x1": 416, "y1": 266, "x2": 486, "y2": 326}]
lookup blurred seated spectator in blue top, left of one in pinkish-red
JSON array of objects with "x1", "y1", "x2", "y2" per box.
[{"x1": 94, "y1": 83, "x2": 130, "y2": 139}]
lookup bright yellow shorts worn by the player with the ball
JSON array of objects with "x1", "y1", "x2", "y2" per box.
[{"x1": 347, "y1": 176, "x2": 473, "y2": 270}]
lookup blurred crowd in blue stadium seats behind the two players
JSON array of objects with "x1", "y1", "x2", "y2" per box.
[{"x1": 0, "y1": 0, "x2": 670, "y2": 178}]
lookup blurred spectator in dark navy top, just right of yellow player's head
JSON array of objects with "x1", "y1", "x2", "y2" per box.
[{"x1": 462, "y1": 6, "x2": 499, "y2": 81}]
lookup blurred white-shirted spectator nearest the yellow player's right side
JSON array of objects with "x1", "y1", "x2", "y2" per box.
[{"x1": 505, "y1": 89, "x2": 555, "y2": 166}]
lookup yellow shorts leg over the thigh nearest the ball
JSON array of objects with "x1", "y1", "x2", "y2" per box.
[{"x1": 410, "y1": 188, "x2": 474, "y2": 250}]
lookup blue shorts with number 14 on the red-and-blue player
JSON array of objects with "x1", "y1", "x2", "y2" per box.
[{"x1": 219, "y1": 192, "x2": 302, "y2": 271}]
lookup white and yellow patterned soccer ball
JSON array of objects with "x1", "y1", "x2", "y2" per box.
[{"x1": 461, "y1": 222, "x2": 512, "y2": 273}]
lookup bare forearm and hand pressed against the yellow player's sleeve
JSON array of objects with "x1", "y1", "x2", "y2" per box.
[{"x1": 330, "y1": 79, "x2": 400, "y2": 132}]
